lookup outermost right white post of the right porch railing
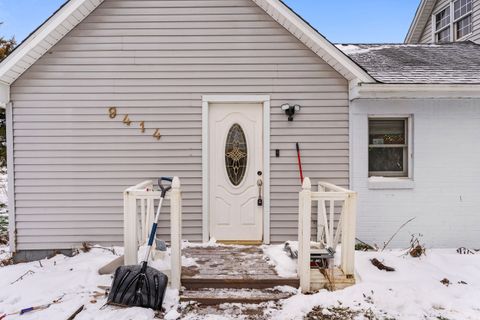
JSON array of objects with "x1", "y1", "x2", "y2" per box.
[{"x1": 342, "y1": 192, "x2": 357, "y2": 277}]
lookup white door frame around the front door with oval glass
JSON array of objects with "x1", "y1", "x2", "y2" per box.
[{"x1": 202, "y1": 95, "x2": 270, "y2": 244}]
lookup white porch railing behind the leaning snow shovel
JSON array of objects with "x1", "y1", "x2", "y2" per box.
[{"x1": 123, "y1": 177, "x2": 182, "y2": 289}]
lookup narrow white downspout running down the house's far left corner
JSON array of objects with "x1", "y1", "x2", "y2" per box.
[{"x1": 0, "y1": 82, "x2": 17, "y2": 252}]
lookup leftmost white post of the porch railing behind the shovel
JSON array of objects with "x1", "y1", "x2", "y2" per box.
[{"x1": 123, "y1": 191, "x2": 138, "y2": 265}]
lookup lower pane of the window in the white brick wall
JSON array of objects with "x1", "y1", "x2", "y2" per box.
[{"x1": 368, "y1": 148, "x2": 406, "y2": 173}]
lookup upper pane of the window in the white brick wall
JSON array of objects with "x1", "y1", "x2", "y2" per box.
[{"x1": 369, "y1": 119, "x2": 406, "y2": 145}]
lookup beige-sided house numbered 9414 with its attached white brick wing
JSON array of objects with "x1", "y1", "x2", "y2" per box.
[{"x1": 0, "y1": 0, "x2": 480, "y2": 259}]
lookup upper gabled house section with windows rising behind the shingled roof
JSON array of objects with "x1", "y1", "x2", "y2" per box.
[{"x1": 405, "y1": 0, "x2": 480, "y2": 44}]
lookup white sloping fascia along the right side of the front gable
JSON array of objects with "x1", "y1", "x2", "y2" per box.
[{"x1": 253, "y1": 0, "x2": 376, "y2": 83}]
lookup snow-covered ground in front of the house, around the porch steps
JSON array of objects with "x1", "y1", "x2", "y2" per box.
[{"x1": 0, "y1": 244, "x2": 480, "y2": 320}]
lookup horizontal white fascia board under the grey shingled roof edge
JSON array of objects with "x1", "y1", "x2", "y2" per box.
[{"x1": 350, "y1": 83, "x2": 480, "y2": 101}]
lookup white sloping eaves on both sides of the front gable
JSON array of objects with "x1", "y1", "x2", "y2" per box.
[{"x1": 0, "y1": 0, "x2": 375, "y2": 85}]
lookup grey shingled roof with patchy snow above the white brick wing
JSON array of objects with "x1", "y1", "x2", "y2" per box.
[{"x1": 338, "y1": 41, "x2": 480, "y2": 84}]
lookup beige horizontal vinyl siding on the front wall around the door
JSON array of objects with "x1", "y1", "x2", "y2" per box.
[{"x1": 11, "y1": 0, "x2": 349, "y2": 250}]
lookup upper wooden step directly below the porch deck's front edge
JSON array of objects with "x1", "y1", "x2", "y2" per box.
[{"x1": 182, "y1": 276, "x2": 300, "y2": 290}]
